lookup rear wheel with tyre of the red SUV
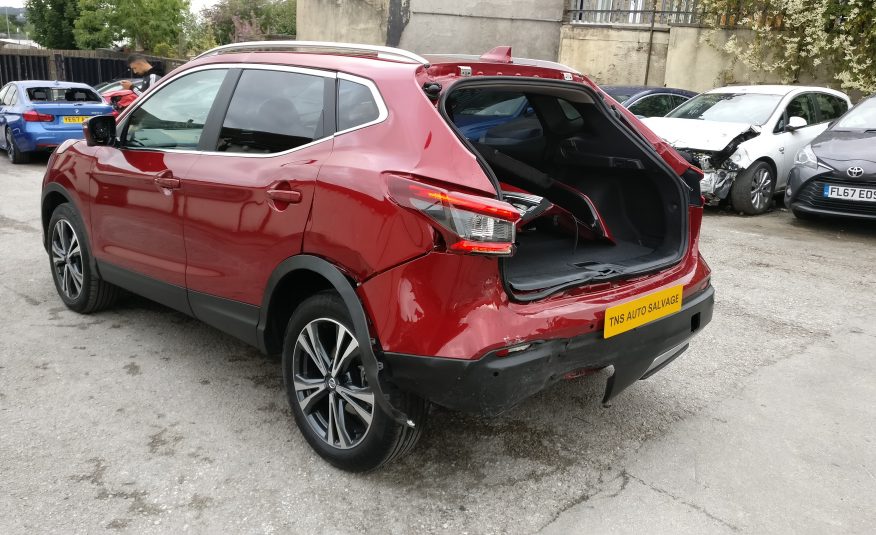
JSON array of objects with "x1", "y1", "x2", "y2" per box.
[{"x1": 283, "y1": 292, "x2": 428, "y2": 472}]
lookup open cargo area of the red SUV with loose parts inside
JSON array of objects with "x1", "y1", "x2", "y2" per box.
[{"x1": 441, "y1": 78, "x2": 688, "y2": 300}]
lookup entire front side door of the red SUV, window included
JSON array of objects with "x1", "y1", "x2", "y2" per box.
[{"x1": 91, "y1": 69, "x2": 228, "y2": 312}]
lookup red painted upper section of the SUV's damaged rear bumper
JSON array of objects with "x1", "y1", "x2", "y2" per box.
[{"x1": 358, "y1": 207, "x2": 710, "y2": 360}]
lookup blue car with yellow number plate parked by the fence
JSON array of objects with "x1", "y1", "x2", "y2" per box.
[{"x1": 0, "y1": 80, "x2": 112, "y2": 163}]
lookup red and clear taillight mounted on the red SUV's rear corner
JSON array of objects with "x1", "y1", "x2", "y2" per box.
[{"x1": 386, "y1": 175, "x2": 520, "y2": 256}]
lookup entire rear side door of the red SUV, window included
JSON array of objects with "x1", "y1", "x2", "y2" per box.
[{"x1": 183, "y1": 66, "x2": 335, "y2": 332}]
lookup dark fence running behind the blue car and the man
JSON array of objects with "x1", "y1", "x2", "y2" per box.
[{"x1": 0, "y1": 48, "x2": 184, "y2": 86}]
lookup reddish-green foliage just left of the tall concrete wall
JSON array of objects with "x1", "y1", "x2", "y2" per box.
[{"x1": 202, "y1": 0, "x2": 296, "y2": 44}]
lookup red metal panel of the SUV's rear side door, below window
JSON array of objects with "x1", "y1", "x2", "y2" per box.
[{"x1": 179, "y1": 142, "x2": 332, "y2": 305}]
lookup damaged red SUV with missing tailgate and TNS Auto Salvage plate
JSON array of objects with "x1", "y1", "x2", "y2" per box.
[{"x1": 42, "y1": 42, "x2": 714, "y2": 471}]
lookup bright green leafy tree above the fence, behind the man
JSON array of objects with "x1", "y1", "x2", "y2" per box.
[{"x1": 75, "y1": 0, "x2": 189, "y2": 51}]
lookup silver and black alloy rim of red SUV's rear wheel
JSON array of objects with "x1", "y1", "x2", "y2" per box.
[{"x1": 292, "y1": 318, "x2": 374, "y2": 449}]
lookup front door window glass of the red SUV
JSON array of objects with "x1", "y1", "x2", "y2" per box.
[{"x1": 124, "y1": 69, "x2": 227, "y2": 150}]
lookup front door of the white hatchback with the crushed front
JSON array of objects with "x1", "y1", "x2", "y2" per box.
[{"x1": 770, "y1": 93, "x2": 827, "y2": 191}]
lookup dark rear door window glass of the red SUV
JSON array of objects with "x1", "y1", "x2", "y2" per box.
[{"x1": 216, "y1": 69, "x2": 326, "y2": 154}]
